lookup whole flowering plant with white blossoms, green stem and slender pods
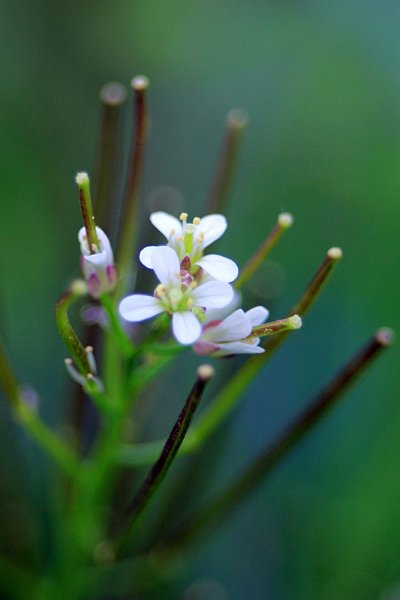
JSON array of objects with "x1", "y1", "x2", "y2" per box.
[{"x1": 0, "y1": 76, "x2": 391, "y2": 600}]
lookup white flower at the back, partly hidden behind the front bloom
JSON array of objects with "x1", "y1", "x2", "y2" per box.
[{"x1": 140, "y1": 211, "x2": 239, "y2": 283}]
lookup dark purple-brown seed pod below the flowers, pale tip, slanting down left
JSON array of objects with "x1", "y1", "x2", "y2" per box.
[{"x1": 114, "y1": 365, "x2": 214, "y2": 554}]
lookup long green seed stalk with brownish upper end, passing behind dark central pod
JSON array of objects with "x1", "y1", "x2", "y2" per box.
[{"x1": 118, "y1": 248, "x2": 342, "y2": 466}]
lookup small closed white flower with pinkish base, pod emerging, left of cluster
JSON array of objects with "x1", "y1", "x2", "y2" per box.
[{"x1": 78, "y1": 227, "x2": 117, "y2": 298}]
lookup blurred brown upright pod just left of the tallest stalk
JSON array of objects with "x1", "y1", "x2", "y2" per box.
[{"x1": 95, "y1": 82, "x2": 127, "y2": 231}]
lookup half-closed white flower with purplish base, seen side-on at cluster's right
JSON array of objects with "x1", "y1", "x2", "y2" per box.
[{"x1": 193, "y1": 306, "x2": 269, "y2": 356}]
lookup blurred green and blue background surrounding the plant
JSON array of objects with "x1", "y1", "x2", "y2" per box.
[{"x1": 0, "y1": 0, "x2": 400, "y2": 600}]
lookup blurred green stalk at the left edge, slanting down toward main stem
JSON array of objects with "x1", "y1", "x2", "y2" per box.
[{"x1": 0, "y1": 330, "x2": 79, "y2": 476}]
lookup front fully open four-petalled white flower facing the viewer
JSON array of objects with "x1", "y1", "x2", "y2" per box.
[{"x1": 119, "y1": 246, "x2": 233, "y2": 344}]
